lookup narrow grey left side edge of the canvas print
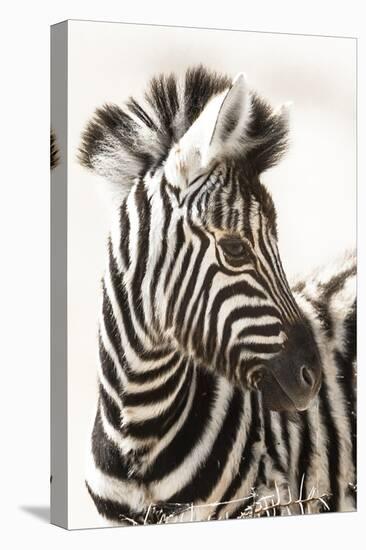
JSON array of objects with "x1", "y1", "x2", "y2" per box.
[{"x1": 50, "y1": 21, "x2": 69, "y2": 529}]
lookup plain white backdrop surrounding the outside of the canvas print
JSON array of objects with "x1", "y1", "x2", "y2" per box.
[{"x1": 0, "y1": 0, "x2": 366, "y2": 549}]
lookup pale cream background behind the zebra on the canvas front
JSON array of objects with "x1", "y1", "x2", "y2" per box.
[{"x1": 67, "y1": 21, "x2": 356, "y2": 528}]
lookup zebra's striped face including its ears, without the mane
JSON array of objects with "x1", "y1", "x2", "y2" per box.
[{"x1": 159, "y1": 76, "x2": 321, "y2": 410}]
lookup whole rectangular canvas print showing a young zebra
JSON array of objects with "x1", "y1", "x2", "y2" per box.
[{"x1": 51, "y1": 21, "x2": 357, "y2": 528}]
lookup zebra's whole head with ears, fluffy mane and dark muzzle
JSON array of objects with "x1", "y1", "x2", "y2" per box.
[{"x1": 81, "y1": 68, "x2": 321, "y2": 410}]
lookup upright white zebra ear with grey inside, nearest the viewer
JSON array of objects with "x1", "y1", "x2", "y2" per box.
[{"x1": 165, "y1": 73, "x2": 251, "y2": 188}]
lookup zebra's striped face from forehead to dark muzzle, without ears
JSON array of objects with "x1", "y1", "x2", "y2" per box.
[{"x1": 160, "y1": 162, "x2": 320, "y2": 410}]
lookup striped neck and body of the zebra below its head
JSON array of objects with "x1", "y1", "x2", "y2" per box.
[{"x1": 87, "y1": 221, "x2": 356, "y2": 523}]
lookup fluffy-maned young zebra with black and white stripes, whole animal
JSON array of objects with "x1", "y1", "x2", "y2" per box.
[{"x1": 80, "y1": 67, "x2": 355, "y2": 523}]
